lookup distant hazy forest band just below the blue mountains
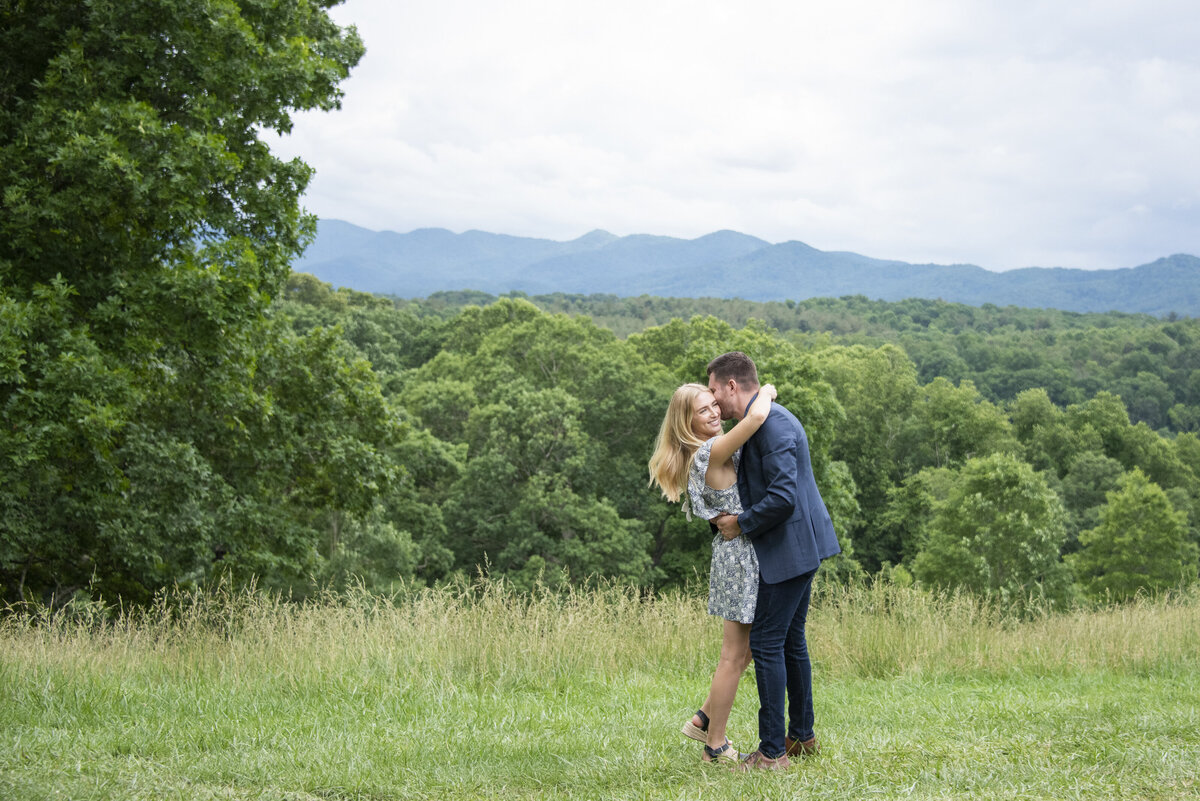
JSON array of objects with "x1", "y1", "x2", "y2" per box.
[{"x1": 410, "y1": 291, "x2": 1200, "y2": 432}]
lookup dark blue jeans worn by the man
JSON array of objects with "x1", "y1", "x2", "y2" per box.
[{"x1": 750, "y1": 571, "x2": 816, "y2": 759}]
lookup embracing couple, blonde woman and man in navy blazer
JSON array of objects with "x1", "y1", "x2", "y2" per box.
[{"x1": 650, "y1": 351, "x2": 841, "y2": 770}]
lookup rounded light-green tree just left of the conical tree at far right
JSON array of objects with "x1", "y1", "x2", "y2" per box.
[{"x1": 912, "y1": 453, "x2": 1070, "y2": 604}]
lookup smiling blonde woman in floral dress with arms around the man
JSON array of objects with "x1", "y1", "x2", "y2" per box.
[{"x1": 650, "y1": 384, "x2": 775, "y2": 763}]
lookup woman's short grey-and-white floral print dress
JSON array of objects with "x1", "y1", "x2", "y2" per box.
[{"x1": 688, "y1": 440, "x2": 758, "y2": 624}]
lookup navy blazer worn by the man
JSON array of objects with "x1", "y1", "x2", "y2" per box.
[{"x1": 738, "y1": 403, "x2": 841, "y2": 584}]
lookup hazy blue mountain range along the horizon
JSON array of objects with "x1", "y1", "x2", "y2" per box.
[{"x1": 293, "y1": 219, "x2": 1200, "y2": 317}]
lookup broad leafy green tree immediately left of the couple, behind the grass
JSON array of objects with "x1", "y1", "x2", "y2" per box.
[{"x1": 400, "y1": 299, "x2": 670, "y2": 584}]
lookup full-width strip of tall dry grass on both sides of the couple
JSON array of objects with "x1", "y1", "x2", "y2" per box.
[{"x1": 0, "y1": 580, "x2": 1200, "y2": 687}]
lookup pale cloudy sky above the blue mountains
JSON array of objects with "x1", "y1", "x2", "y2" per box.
[{"x1": 272, "y1": 0, "x2": 1200, "y2": 270}]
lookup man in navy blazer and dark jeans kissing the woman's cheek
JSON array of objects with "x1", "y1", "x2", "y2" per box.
[{"x1": 708, "y1": 351, "x2": 841, "y2": 770}]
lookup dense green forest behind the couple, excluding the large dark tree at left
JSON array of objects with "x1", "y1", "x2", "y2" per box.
[{"x1": 265, "y1": 275, "x2": 1200, "y2": 598}]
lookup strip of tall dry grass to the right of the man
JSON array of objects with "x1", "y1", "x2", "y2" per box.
[{"x1": 810, "y1": 582, "x2": 1200, "y2": 677}]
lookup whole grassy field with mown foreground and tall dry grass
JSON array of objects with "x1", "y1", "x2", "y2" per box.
[{"x1": 0, "y1": 575, "x2": 1200, "y2": 801}]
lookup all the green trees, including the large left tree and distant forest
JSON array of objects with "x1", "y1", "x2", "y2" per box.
[{"x1": 0, "y1": 2, "x2": 1200, "y2": 603}]
